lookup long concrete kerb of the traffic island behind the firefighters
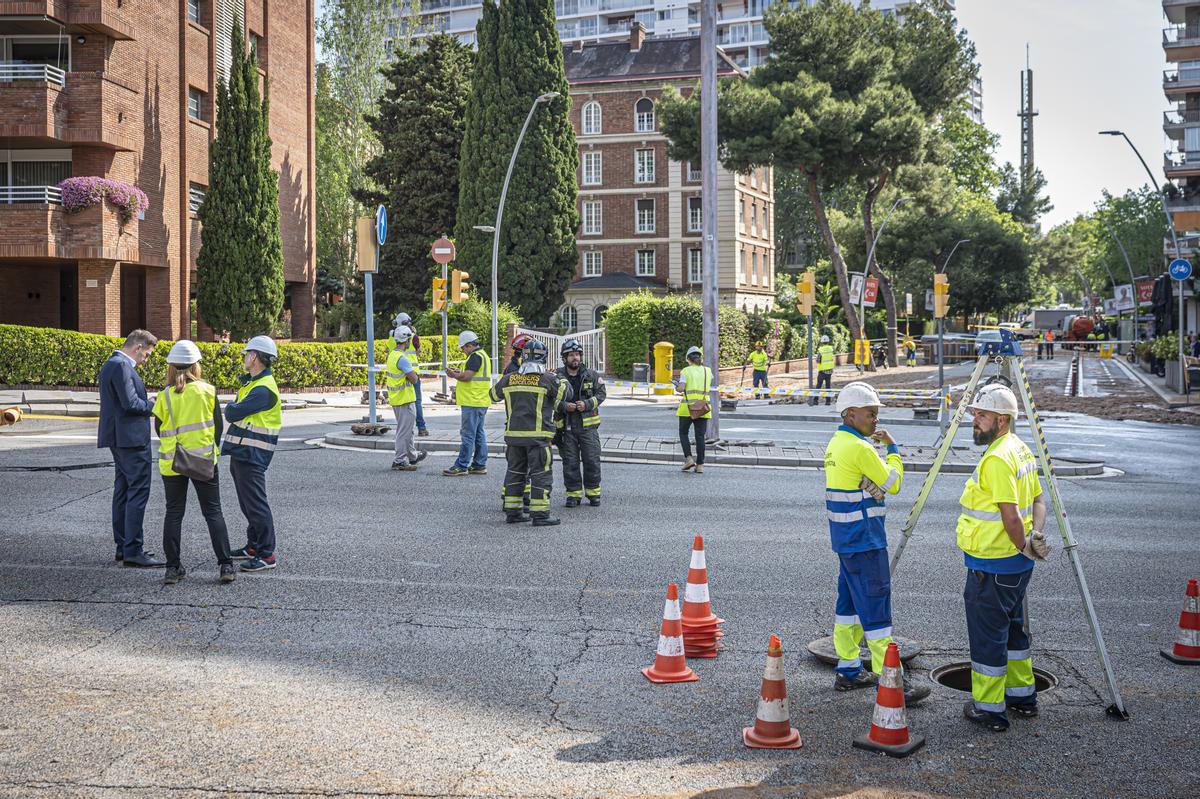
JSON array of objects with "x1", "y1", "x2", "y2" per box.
[{"x1": 324, "y1": 432, "x2": 1104, "y2": 477}]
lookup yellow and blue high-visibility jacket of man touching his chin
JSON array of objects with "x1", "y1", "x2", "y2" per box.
[{"x1": 826, "y1": 425, "x2": 904, "y2": 553}]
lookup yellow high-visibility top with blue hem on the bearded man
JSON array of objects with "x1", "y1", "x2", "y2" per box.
[{"x1": 958, "y1": 433, "x2": 1042, "y2": 573}]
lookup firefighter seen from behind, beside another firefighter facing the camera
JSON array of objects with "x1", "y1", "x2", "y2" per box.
[{"x1": 492, "y1": 340, "x2": 569, "y2": 527}]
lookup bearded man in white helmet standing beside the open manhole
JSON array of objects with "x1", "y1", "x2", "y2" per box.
[{"x1": 956, "y1": 383, "x2": 1050, "y2": 732}]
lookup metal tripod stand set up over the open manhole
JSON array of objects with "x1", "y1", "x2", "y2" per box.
[{"x1": 890, "y1": 354, "x2": 1129, "y2": 720}]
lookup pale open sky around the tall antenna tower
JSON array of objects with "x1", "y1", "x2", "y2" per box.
[{"x1": 956, "y1": 0, "x2": 1170, "y2": 229}]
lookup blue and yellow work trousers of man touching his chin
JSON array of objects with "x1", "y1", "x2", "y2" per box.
[{"x1": 833, "y1": 549, "x2": 892, "y2": 679}]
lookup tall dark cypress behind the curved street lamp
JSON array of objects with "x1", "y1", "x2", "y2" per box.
[{"x1": 455, "y1": 0, "x2": 578, "y2": 322}]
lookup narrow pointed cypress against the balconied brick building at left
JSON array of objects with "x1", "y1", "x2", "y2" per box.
[{"x1": 196, "y1": 14, "x2": 283, "y2": 340}]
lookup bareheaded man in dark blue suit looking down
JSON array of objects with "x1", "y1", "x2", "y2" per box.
[{"x1": 96, "y1": 330, "x2": 163, "y2": 567}]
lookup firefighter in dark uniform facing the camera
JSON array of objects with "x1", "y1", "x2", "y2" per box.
[{"x1": 556, "y1": 338, "x2": 607, "y2": 507}]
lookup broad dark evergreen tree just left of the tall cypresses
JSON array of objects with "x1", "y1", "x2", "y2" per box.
[{"x1": 356, "y1": 34, "x2": 478, "y2": 320}]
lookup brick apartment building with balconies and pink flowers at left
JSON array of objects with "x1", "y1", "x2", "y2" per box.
[{"x1": 0, "y1": 0, "x2": 316, "y2": 338}]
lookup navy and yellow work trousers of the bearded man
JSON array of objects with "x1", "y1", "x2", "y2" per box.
[{"x1": 962, "y1": 569, "x2": 1038, "y2": 723}]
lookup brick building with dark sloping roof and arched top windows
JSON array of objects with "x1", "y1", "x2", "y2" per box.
[{"x1": 559, "y1": 23, "x2": 775, "y2": 330}]
